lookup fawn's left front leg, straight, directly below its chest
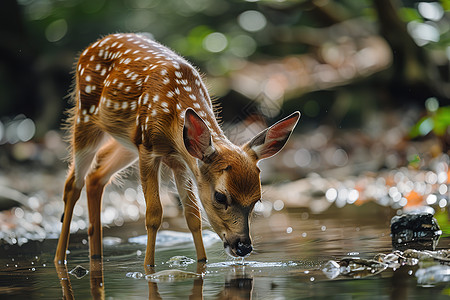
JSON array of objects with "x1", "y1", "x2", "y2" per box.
[{"x1": 139, "y1": 154, "x2": 162, "y2": 272}]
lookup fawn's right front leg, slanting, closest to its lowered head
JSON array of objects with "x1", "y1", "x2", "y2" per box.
[{"x1": 173, "y1": 166, "x2": 206, "y2": 262}]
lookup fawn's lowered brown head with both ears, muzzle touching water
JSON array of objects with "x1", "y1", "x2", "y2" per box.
[{"x1": 183, "y1": 109, "x2": 300, "y2": 257}]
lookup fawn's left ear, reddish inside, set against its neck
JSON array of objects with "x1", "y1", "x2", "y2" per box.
[{"x1": 183, "y1": 108, "x2": 215, "y2": 162}]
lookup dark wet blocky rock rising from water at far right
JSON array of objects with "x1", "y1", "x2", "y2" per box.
[{"x1": 391, "y1": 213, "x2": 442, "y2": 250}]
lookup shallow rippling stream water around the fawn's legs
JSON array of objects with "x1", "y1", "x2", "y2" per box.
[{"x1": 0, "y1": 203, "x2": 450, "y2": 299}]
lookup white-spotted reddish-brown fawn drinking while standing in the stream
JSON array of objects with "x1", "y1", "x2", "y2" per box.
[{"x1": 55, "y1": 34, "x2": 300, "y2": 267}]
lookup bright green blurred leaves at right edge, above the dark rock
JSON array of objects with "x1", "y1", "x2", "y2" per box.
[{"x1": 409, "y1": 98, "x2": 450, "y2": 138}]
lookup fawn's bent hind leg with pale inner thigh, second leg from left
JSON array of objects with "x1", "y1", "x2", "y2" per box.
[{"x1": 86, "y1": 139, "x2": 137, "y2": 259}]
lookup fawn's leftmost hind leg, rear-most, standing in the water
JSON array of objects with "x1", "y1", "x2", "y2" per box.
[{"x1": 54, "y1": 126, "x2": 103, "y2": 264}]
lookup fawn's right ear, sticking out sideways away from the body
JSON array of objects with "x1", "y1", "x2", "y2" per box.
[{"x1": 246, "y1": 111, "x2": 300, "y2": 160}]
